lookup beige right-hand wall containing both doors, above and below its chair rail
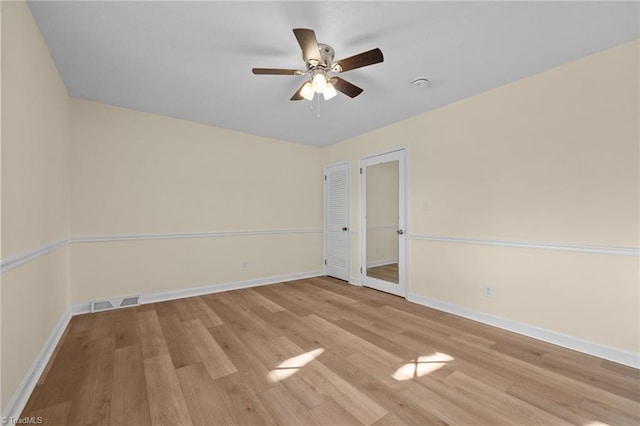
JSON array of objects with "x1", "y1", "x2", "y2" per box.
[{"x1": 326, "y1": 42, "x2": 640, "y2": 353}]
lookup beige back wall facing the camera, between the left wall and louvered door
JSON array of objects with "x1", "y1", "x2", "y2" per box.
[{"x1": 71, "y1": 99, "x2": 322, "y2": 303}]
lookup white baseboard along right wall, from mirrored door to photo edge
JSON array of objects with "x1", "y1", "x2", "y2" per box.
[{"x1": 407, "y1": 293, "x2": 640, "y2": 368}]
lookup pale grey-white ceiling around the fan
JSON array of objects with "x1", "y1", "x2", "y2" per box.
[{"x1": 29, "y1": 1, "x2": 639, "y2": 146}]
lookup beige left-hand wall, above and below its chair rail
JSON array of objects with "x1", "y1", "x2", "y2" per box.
[{"x1": 0, "y1": 2, "x2": 69, "y2": 409}]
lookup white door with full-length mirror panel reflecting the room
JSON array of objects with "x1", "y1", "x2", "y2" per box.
[{"x1": 359, "y1": 149, "x2": 407, "y2": 297}]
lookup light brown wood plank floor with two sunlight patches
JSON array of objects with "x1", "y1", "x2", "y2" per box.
[{"x1": 23, "y1": 278, "x2": 640, "y2": 426}]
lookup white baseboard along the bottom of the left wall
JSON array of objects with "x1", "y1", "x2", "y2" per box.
[{"x1": 2, "y1": 309, "x2": 72, "y2": 423}]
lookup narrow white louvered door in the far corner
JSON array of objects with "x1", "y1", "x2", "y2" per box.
[{"x1": 324, "y1": 162, "x2": 350, "y2": 281}]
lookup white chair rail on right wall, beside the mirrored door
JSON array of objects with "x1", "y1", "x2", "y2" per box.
[{"x1": 409, "y1": 235, "x2": 640, "y2": 257}]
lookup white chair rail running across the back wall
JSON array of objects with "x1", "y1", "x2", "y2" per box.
[{"x1": 70, "y1": 228, "x2": 322, "y2": 243}]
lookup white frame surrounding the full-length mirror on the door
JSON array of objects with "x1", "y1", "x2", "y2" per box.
[{"x1": 358, "y1": 147, "x2": 408, "y2": 299}]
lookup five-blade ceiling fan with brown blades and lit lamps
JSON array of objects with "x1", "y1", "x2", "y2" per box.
[{"x1": 252, "y1": 28, "x2": 384, "y2": 101}]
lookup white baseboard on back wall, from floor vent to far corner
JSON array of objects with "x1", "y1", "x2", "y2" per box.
[{"x1": 139, "y1": 270, "x2": 324, "y2": 305}]
